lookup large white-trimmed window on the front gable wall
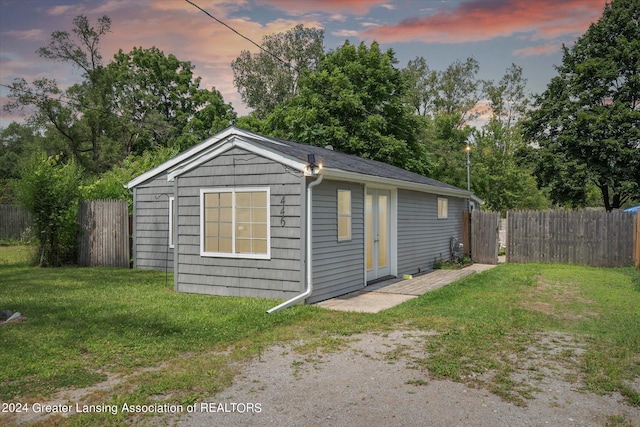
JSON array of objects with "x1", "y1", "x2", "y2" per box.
[{"x1": 200, "y1": 187, "x2": 271, "y2": 259}]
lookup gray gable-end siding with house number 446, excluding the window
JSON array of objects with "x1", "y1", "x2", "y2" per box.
[{"x1": 175, "y1": 148, "x2": 304, "y2": 299}]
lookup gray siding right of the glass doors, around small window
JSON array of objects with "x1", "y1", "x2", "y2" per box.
[{"x1": 397, "y1": 190, "x2": 466, "y2": 275}]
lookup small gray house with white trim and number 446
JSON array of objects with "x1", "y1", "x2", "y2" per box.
[{"x1": 127, "y1": 127, "x2": 477, "y2": 309}]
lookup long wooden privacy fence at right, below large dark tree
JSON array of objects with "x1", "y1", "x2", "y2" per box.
[{"x1": 507, "y1": 211, "x2": 638, "y2": 267}]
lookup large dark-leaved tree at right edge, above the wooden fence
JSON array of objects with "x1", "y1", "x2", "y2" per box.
[{"x1": 525, "y1": 0, "x2": 640, "y2": 211}]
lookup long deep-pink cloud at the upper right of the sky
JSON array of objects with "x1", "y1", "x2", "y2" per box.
[{"x1": 362, "y1": 0, "x2": 606, "y2": 43}]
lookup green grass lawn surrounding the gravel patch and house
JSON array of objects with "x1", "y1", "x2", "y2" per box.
[{"x1": 0, "y1": 247, "x2": 640, "y2": 425}]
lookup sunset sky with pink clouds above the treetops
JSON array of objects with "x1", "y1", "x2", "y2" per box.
[{"x1": 0, "y1": 0, "x2": 606, "y2": 127}]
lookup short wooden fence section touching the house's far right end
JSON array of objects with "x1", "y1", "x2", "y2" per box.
[{"x1": 471, "y1": 209, "x2": 500, "y2": 265}]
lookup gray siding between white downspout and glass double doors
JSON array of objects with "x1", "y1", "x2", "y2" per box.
[{"x1": 307, "y1": 181, "x2": 365, "y2": 303}]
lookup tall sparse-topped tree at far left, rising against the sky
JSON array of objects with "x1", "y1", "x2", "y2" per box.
[{"x1": 5, "y1": 15, "x2": 112, "y2": 172}]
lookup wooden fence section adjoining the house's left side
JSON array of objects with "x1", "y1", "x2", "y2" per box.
[{"x1": 78, "y1": 200, "x2": 130, "y2": 267}]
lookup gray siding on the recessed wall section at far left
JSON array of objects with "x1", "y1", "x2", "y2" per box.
[{"x1": 132, "y1": 174, "x2": 173, "y2": 271}]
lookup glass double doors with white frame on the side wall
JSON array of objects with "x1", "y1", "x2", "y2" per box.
[{"x1": 365, "y1": 188, "x2": 391, "y2": 282}]
